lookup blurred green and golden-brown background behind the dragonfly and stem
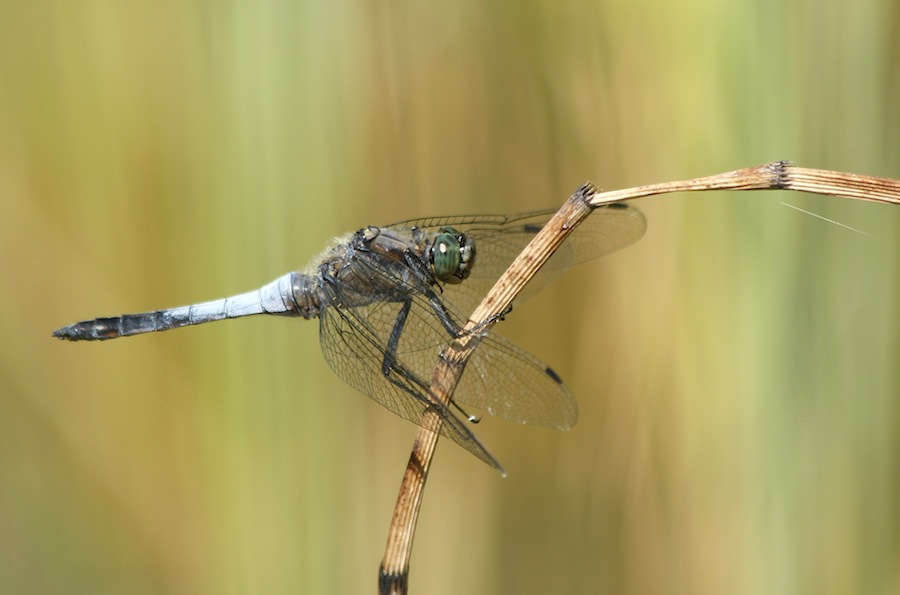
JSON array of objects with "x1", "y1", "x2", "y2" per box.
[{"x1": 0, "y1": 0, "x2": 900, "y2": 594}]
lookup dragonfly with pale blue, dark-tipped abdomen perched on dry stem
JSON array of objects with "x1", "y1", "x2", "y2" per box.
[{"x1": 53, "y1": 203, "x2": 646, "y2": 472}]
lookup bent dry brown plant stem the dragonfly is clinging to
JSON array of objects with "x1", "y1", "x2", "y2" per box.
[{"x1": 379, "y1": 161, "x2": 900, "y2": 595}]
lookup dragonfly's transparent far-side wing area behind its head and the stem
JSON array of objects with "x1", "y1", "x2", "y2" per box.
[{"x1": 396, "y1": 203, "x2": 647, "y2": 322}]
